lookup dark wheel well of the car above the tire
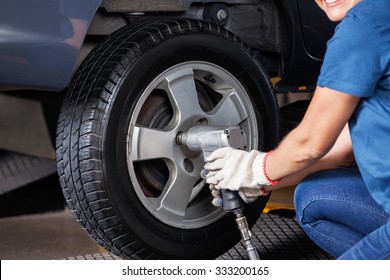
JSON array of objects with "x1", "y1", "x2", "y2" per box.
[{"x1": 78, "y1": 0, "x2": 287, "y2": 76}]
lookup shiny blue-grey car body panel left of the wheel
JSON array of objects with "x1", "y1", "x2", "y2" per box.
[{"x1": 0, "y1": 0, "x2": 102, "y2": 91}]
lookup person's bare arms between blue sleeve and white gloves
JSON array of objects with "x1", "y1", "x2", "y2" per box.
[{"x1": 266, "y1": 87, "x2": 360, "y2": 187}]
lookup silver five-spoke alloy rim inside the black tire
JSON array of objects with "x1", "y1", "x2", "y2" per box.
[{"x1": 127, "y1": 61, "x2": 258, "y2": 229}]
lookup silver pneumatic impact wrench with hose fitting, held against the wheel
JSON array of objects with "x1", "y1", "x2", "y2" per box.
[{"x1": 177, "y1": 126, "x2": 259, "y2": 260}]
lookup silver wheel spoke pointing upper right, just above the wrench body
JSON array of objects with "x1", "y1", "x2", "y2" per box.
[{"x1": 209, "y1": 90, "x2": 248, "y2": 126}]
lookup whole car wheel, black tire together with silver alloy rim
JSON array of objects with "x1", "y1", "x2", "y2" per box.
[{"x1": 56, "y1": 19, "x2": 279, "y2": 259}]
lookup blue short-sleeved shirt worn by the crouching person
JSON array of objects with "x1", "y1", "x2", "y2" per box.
[{"x1": 318, "y1": 0, "x2": 390, "y2": 213}]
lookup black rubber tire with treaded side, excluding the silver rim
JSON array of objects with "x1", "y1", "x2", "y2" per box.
[{"x1": 56, "y1": 19, "x2": 279, "y2": 259}]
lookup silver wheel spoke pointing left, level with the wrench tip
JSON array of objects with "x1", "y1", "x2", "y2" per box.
[{"x1": 129, "y1": 126, "x2": 175, "y2": 161}]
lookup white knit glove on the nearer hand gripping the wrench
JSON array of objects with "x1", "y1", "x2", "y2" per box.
[{"x1": 204, "y1": 147, "x2": 277, "y2": 191}]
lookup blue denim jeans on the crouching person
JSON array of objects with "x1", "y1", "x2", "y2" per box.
[{"x1": 294, "y1": 168, "x2": 390, "y2": 260}]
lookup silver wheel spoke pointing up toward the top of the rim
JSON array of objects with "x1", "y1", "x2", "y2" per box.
[{"x1": 160, "y1": 68, "x2": 204, "y2": 123}]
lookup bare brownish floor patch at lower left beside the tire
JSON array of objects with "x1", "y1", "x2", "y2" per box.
[{"x1": 0, "y1": 210, "x2": 106, "y2": 260}]
